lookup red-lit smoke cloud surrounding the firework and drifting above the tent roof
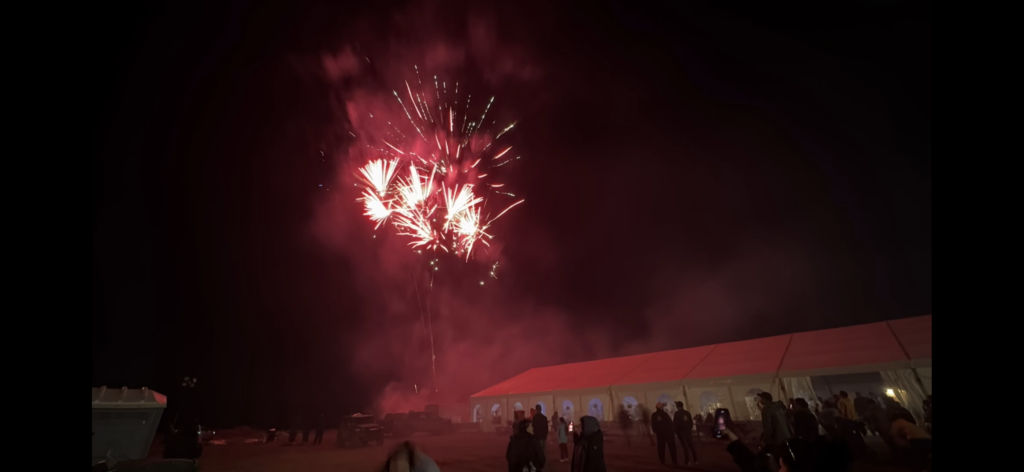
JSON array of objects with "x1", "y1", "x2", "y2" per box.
[{"x1": 303, "y1": 0, "x2": 839, "y2": 413}]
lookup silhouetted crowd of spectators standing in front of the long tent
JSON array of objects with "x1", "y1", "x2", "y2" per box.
[{"x1": 384, "y1": 391, "x2": 932, "y2": 472}]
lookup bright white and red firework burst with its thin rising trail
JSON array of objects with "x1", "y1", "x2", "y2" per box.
[{"x1": 356, "y1": 66, "x2": 523, "y2": 389}]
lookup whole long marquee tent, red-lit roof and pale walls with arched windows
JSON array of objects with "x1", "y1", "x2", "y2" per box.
[{"x1": 469, "y1": 315, "x2": 932, "y2": 431}]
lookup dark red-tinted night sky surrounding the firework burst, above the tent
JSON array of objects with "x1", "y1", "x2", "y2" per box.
[{"x1": 92, "y1": 1, "x2": 932, "y2": 427}]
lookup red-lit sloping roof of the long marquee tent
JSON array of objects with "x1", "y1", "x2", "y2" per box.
[{"x1": 472, "y1": 315, "x2": 932, "y2": 397}]
